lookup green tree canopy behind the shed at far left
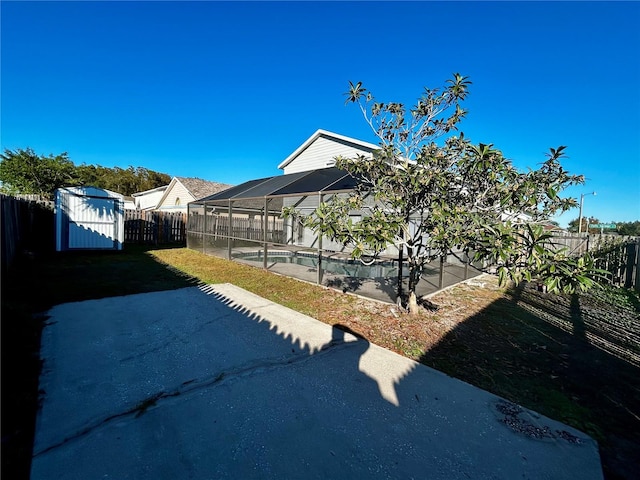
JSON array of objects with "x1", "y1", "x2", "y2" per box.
[{"x1": 0, "y1": 148, "x2": 171, "y2": 199}]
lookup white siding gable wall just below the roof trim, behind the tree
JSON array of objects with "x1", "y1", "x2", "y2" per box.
[{"x1": 284, "y1": 136, "x2": 371, "y2": 175}]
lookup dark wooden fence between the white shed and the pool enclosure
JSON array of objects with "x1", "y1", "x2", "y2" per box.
[{"x1": 124, "y1": 210, "x2": 187, "y2": 245}]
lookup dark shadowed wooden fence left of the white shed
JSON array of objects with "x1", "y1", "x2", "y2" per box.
[{"x1": 0, "y1": 194, "x2": 55, "y2": 274}]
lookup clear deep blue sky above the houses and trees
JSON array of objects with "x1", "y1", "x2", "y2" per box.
[{"x1": 0, "y1": 1, "x2": 640, "y2": 225}]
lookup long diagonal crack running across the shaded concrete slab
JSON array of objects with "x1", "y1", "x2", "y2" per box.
[{"x1": 33, "y1": 340, "x2": 358, "y2": 458}]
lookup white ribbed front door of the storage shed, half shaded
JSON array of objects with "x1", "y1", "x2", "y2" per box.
[{"x1": 67, "y1": 195, "x2": 118, "y2": 249}]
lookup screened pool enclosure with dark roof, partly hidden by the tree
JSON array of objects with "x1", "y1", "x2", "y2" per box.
[{"x1": 187, "y1": 167, "x2": 480, "y2": 302}]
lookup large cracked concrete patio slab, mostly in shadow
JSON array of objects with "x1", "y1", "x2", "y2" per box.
[{"x1": 31, "y1": 284, "x2": 602, "y2": 480}]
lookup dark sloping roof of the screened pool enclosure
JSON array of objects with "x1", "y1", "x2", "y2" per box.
[{"x1": 192, "y1": 167, "x2": 358, "y2": 203}]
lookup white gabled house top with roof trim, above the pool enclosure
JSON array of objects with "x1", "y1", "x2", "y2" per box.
[{"x1": 278, "y1": 130, "x2": 380, "y2": 175}]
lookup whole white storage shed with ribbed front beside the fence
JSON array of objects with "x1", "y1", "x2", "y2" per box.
[{"x1": 55, "y1": 187, "x2": 124, "y2": 252}]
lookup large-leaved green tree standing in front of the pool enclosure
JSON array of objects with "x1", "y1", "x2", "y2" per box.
[{"x1": 292, "y1": 74, "x2": 604, "y2": 312}]
